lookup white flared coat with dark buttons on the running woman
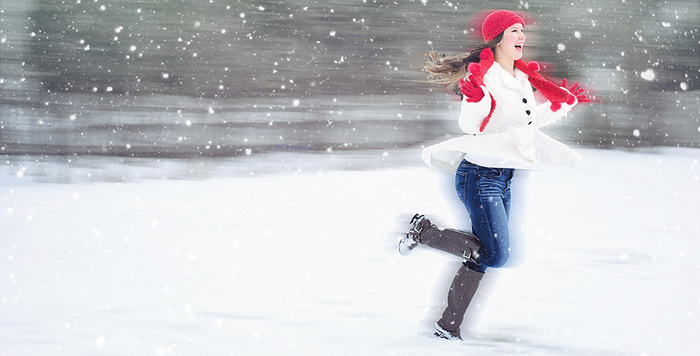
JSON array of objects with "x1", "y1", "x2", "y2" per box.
[{"x1": 422, "y1": 62, "x2": 581, "y2": 171}]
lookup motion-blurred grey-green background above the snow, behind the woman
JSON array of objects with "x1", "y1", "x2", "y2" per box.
[{"x1": 0, "y1": 0, "x2": 700, "y2": 154}]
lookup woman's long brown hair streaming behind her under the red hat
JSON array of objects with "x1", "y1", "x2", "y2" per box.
[{"x1": 423, "y1": 32, "x2": 503, "y2": 96}]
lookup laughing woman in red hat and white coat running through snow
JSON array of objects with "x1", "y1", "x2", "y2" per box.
[{"x1": 399, "y1": 10, "x2": 588, "y2": 340}]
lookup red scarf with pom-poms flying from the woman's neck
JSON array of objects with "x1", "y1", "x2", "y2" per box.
[{"x1": 468, "y1": 48, "x2": 576, "y2": 132}]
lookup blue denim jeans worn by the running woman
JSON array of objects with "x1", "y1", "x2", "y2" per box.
[{"x1": 455, "y1": 160, "x2": 515, "y2": 272}]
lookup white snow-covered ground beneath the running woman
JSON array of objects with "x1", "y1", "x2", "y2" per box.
[{"x1": 0, "y1": 148, "x2": 700, "y2": 356}]
